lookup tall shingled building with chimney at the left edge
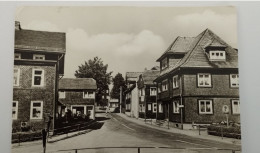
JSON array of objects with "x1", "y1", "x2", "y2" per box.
[{"x1": 12, "y1": 22, "x2": 66, "y2": 131}]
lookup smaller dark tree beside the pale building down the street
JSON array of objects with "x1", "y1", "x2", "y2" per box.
[{"x1": 110, "y1": 73, "x2": 126, "y2": 99}]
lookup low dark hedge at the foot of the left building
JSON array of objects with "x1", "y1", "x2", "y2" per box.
[{"x1": 12, "y1": 131, "x2": 42, "y2": 143}]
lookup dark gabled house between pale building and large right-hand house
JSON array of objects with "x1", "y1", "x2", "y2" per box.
[{"x1": 137, "y1": 69, "x2": 160, "y2": 119}]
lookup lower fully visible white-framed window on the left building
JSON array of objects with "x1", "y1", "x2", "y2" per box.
[{"x1": 30, "y1": 101, "x2": 43, "y2": 119}]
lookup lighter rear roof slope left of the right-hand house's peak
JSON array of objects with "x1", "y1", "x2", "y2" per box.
[{"x1": 157, "y1": 36, "x2": 195, "y2": 62}]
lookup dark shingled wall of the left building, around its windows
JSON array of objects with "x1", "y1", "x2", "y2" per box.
[{"x1": 13, "y1": 65, "x2": 56, "y2": 130}]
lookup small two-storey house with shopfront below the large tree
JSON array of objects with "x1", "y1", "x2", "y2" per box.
[{"x1": 58, "y1": 78, "x2": 97, "y2": 119}]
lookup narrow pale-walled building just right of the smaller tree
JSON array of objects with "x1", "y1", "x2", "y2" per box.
[{"x1": 125, "y1": 72, "x2": 142, "y2": 118}]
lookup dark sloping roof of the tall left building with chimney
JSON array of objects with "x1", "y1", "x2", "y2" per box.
[{"x1": 15, "y1": 26, "x2": 66, "y2": 53}]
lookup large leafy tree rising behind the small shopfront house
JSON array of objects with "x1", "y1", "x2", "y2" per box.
[{"x1": 75, "y1": 57, "x2": 112, "y2": 106}]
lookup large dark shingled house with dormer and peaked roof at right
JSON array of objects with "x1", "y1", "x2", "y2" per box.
[{"x1": 152, "y1": 29, "x2": 240, "y2": 127}]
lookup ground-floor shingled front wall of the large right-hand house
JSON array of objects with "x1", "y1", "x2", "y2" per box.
[{"x1": 184, "y1": 97, "x2": 240, "y2": 123}]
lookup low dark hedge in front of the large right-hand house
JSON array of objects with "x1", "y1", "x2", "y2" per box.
[{"x1": 207, "y1": 125, "x2": 241, "y2": 139}]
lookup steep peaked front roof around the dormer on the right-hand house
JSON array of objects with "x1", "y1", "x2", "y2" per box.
[{"x1": 155, "y1": 29, "x2": 238, "y2": 81}]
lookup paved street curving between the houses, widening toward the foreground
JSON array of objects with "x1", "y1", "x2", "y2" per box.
[{"x1": 12, "y1": 114, "x2": 239, "y2": 153}]
